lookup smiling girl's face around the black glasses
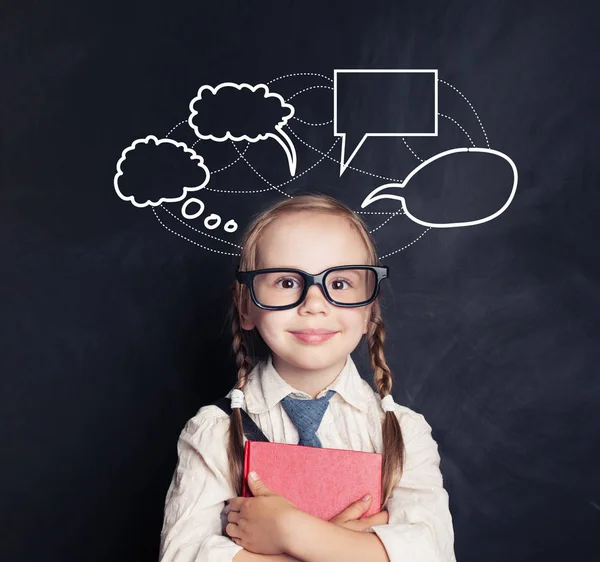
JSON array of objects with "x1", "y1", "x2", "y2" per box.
[{"x1": 242, "y1": 212, "x2": 372, "y2": 371}]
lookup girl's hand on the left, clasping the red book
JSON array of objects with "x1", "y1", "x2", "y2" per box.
[{"x1": 225, "y1": 473, "x2": 298, "y2": 554}]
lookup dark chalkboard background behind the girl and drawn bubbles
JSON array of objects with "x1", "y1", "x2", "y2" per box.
[{"x1": 0, "y1": 0, "x2": 600, "y2": 562}]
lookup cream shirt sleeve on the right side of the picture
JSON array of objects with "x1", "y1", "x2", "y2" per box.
[{"x1": 371, "y1": 410, "x2": 456, "y2": 562}]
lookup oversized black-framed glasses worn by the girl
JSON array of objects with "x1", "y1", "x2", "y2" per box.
[{"x1": 236, "y1": 265, "x2": 389, "y2": 310}]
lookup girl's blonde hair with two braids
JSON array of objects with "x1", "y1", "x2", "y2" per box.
[{"x1": 228, "y1": 194, "x2": 404, "y2": 506}]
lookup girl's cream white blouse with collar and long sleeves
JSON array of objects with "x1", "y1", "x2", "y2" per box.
[{"x1": 160, "y1": 355, "x2": 456, "y2": 562}]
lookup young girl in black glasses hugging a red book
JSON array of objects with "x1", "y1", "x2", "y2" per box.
[{"x1": 160, "y1": 195, "x2": 455, "y2": 562}]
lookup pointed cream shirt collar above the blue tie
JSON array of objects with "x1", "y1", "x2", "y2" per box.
[{"x1": 238, "y1": 355, "x2": 372, "y2": 414}]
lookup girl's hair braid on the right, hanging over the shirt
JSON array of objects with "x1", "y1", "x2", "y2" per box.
[{"x1": 367, "y1": 301, "x2": 404, "y2": 506}]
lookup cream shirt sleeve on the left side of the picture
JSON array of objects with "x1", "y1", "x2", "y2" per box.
[{"x1": 159, "y1": 406, "x2": 243, "y2": 562}]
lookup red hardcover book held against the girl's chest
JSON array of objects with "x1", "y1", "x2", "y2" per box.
[{"x1": 242, "y1": 441, "x2": 382, "y2": 521}]
